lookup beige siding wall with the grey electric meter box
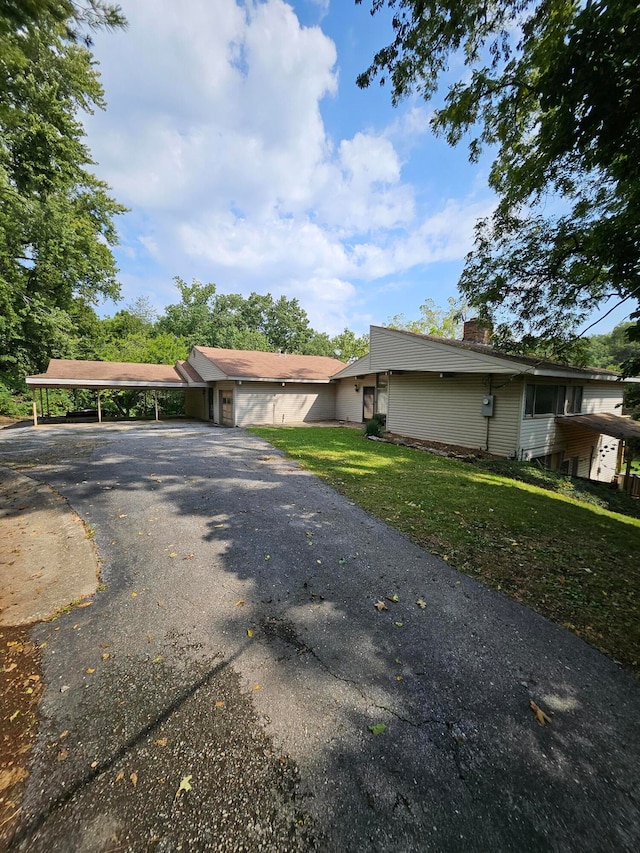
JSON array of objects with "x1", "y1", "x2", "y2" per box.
[{"x1": 387, "y1": 373, "x2": 520, "y2": 456}]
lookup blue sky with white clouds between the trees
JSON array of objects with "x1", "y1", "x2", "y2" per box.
[{"x1": 86, "y1": 0, "x2": 628, "y2": 334}]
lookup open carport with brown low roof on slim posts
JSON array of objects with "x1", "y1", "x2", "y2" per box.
[{"x1": 26, "y1": 358, "x2": 208, "y2": 426}]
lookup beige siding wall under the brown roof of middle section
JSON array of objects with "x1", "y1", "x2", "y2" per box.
[{"x1": 235, "y1": 382, "x2": 336, "y2": 426}]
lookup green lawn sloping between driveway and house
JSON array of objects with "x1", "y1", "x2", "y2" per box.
[{"x1": 252, "y1": 427, "x2": 640, "y2": 671}]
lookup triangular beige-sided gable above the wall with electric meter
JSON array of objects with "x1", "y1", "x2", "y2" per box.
[{"x1": 370, "y1": 326, "x2": 517, "y2": 374}]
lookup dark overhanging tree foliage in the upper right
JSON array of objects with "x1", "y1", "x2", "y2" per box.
[{"x1": 356, "y1": 0, "x2": 640, "y2": 369}]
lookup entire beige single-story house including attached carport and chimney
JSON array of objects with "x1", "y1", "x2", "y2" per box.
[{"x1": 27, "y1": 320, "x2": 640, "y2": 481}]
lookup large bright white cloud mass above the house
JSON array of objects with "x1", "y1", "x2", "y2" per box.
[{"x1": 88, "y1": 0, "x2": 486, "y2": 331}]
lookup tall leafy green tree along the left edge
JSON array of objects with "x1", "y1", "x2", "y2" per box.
[{"x1": 0, "y1": 0, "x2": 124, "y2": 381}]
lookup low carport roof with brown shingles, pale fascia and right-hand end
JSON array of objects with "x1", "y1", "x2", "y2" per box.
[{"x1": 26, "y1": 358, "x2": 207, "y2": 390}]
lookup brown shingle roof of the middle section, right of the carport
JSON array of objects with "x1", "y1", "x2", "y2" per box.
[{"x1": 195, "y1": 347, "x2": 345, "y2": 382}]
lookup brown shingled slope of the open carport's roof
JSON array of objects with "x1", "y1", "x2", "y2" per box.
[{"x1": 27, "y1": 358, "x2": 202, "y2": 386}]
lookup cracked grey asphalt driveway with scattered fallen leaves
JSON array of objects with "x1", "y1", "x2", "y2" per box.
[{"x1": 0, "y1": 424, "x2": 640, "y2": 853}]
